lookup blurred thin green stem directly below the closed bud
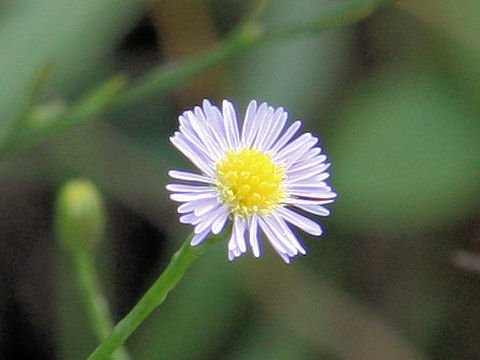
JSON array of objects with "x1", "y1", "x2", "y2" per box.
[{"x1": 73, "y1": 252, "x2": 130, "y2": 360}]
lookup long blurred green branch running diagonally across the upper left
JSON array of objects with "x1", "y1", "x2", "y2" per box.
[{"x1": 0, "y1": 0, "x2": 395, "y2": 157}]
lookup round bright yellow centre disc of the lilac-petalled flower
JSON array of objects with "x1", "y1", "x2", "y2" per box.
[{"x1": 216, "y1": 148, "x2": 286, "y2": 217}]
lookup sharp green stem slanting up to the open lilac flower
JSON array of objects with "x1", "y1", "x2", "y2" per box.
[{"x1": 88, "y1": 233, "x2": 215, "y2": 360}]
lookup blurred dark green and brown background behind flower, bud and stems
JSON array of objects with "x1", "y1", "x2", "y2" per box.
[{"x1": 0, "y1": 0, "x2": 480, "y2": 360}]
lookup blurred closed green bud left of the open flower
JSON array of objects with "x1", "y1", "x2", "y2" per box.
[{"x1": 55, "y1": 179, "x2": 105, "y2": 252}]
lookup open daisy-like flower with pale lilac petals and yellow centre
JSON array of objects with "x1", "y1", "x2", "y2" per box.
[{"x1": 167, "y1": 100, "x2": 337, "y2": 263}]
